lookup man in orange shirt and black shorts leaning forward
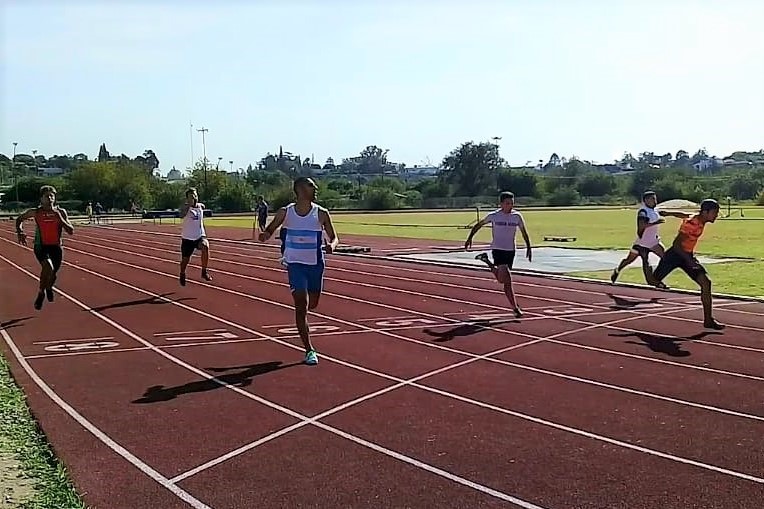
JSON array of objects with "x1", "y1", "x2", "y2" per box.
[{"x1": 654, "y1": 199, "x2": 724, "y2": 330}]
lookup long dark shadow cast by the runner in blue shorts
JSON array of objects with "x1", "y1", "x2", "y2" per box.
[{"x1": 132, "y1": 361, "x2": 302, "y2": 404}]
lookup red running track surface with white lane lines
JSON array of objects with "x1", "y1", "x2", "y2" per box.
[{"x1": 0, "y1": 225, "x2": 764, "y2": 509}]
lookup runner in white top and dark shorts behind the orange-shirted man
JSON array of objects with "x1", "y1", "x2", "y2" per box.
[{"x1": 610, "y1": 191, "x2": 690, "y2": 289}]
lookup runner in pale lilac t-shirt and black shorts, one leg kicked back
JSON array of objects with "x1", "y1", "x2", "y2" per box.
[{"x1": 464, "y1": 191, "x2": 532, "y2": 318}]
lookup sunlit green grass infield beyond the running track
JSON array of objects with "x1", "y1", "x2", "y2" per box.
[{"x1": 207, "y1": 207, "x2": 764, "y2": 296}]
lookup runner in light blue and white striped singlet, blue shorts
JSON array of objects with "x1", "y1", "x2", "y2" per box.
[{"x1": 260, "y1": 177, "x2": 339, "y2": 365}]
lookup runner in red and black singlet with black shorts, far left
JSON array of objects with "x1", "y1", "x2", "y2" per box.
[{"x1": 16, "y1": 186, "x2": 74, "y2": 310}]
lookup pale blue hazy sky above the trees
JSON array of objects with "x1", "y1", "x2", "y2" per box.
[{"x1": 0, "y1": 0, "x2": 764, "y2": 174}]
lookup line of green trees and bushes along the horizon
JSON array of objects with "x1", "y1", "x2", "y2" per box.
[{"x1": 0, "y1": 142, "x2": 764, "y2": 213}]
